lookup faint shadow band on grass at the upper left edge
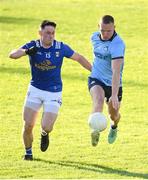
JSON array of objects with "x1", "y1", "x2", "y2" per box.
[{"x1": 0, "y1": 16, "x2": 40, "y2": 25}]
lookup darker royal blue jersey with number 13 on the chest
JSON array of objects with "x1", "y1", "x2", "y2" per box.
[{"x1": 21, "y1": 40, "x2": 74, "y2": 92}]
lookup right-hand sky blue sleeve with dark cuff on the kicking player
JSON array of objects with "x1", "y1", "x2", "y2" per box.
[{"x1": 111, "y1": 42, "x2": 125, "y2": 60}]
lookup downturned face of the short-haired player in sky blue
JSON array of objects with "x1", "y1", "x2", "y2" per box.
[{"x1": 100, "y1": 23, "x2": 115, "y2": 40}]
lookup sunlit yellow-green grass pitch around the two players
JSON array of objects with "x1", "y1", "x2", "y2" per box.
[{"x1": 0, "y1": 0, "x2": 148, "y2": 179}]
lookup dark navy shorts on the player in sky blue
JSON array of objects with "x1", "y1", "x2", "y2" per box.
[{"x1": 88, "y1": 77, "x2": 122, "y2": 102}]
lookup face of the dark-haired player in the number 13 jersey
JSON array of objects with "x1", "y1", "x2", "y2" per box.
[{"x1": 40, "y1": 26, "x2": 55, "y2": 46}]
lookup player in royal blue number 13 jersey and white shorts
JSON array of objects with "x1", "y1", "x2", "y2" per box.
[{"x1": 9, "y1": 20, "x2": 91, "y2": 160}]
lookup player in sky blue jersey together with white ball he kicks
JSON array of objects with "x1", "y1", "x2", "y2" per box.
[{"x1": 88, "y1": 15, "x2": 125, "y2": 146}]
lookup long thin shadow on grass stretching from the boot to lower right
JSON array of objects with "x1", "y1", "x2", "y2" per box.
[{"x1": 34, "y1": 158, "x2": 148, "y2": 179}]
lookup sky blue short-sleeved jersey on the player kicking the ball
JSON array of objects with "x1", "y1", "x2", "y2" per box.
[{"x1": 90, "y1": 32, "x2": 125, "y2": 86}]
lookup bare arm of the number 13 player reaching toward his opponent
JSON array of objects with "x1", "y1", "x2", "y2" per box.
[{"x1": 70, "y1": 53, "x2": 92, "y2": 71}]
